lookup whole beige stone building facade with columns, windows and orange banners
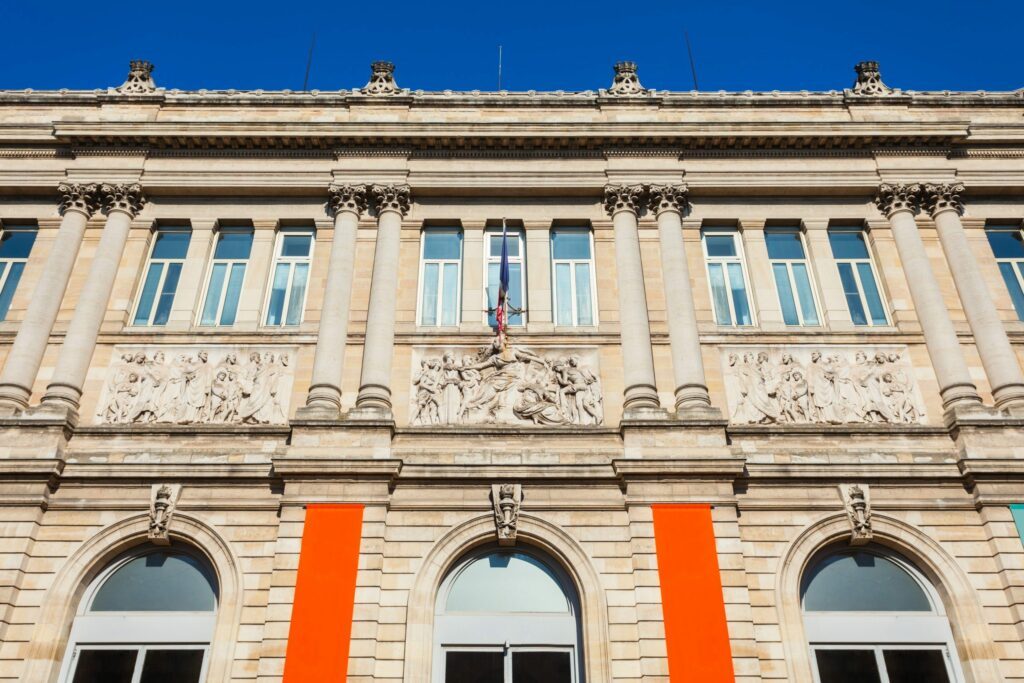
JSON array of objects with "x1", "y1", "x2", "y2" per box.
[{"x1": 0, "y1": 62, "x2": 1024, "y2": 683}]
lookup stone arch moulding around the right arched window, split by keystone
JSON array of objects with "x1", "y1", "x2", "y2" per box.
[{"x1": 775, "y1": 512, "x2": 1002, "y2": 683}]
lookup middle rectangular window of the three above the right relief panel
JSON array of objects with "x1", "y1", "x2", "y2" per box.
[{"x1": 765, "y1": 227, "x2": 818, "y2": 326}]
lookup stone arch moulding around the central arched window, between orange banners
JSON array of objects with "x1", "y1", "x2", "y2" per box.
[{"x1": 402, "y1": 514, "x2": 611, "y2": 683}]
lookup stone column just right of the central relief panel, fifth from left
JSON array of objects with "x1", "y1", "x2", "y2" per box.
[{"x1": 604, "y1": 185, "x2": 660, "y2": 417}]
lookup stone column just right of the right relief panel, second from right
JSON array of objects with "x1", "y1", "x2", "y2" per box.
[{"x1": 874, "y1": 183, "x2": 981, "y2": 412}]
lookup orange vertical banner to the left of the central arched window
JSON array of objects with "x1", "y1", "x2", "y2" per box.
[{"x1": 284, "y1": 505, "x2": 362, "y2": 683}]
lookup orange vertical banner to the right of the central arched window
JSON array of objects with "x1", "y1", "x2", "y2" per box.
[{"x1": 651, "y1": 505, "x2": 735, "y2": 683}]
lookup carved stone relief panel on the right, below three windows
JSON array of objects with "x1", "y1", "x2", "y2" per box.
[{"x1": 722, "y1": 345, "x2": 925, "y2": 424}]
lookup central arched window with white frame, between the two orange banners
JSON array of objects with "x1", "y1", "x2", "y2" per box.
[{"x1": 434, "y1": 547, "x2": 583, "y2": 683}]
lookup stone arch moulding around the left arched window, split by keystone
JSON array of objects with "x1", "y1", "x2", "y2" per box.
[{"x1": 22, "y1": 512, "x2": 243, "y2": 683}]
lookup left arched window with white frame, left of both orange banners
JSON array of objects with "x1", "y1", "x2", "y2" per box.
[{"x1": 60, "y1": 546, "x2": 217, "y2": 683}]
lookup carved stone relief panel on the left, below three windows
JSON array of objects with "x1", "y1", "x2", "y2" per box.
[{"x1": 96, "y1": 346, "x2": 295, "y2": 425}]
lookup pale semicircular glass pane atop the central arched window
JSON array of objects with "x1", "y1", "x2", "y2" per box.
[{"x1": 444, "y1": 550, "x2": 569, "y2": 613}]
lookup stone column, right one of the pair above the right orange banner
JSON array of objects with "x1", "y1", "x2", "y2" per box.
[{"x1": 649, "y1": 185, "x2": 711, "y2": 417}]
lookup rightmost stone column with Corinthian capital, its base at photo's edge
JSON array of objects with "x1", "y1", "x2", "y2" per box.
[{"x1": 925, "y1": 182, "x2": 1024, "y2": 412}]
